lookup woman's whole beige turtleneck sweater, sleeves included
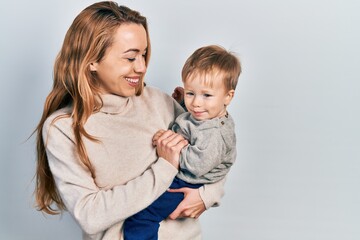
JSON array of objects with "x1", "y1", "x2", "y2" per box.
[{"x1": 43, "y1": 86, "x2": 225, "y2": 240}]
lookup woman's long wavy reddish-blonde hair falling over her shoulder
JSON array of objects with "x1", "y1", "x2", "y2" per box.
[{"x1": 35, "y1": 1, "x2": 150, "y2": 214}]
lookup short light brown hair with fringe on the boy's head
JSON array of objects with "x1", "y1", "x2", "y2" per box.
[{"x1": 181, "y1": 45, "x2": 241, "y2": 91}]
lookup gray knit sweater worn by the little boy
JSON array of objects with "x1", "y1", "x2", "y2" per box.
[{"x1": 172, "y1": 112, "x2": 236, "y2": 184}]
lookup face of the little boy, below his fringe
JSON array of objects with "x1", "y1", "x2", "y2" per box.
[{"x1": 184, "y1": 74, "x2": 234, "y2": 121}]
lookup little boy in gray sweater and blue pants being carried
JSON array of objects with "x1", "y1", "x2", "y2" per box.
[{"x1": 124, "y1": 45, "x2": 241, "y2": 240}]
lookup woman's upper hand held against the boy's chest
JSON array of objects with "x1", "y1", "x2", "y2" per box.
[{"x1": 153, "y1": 130, "x2": 188, "y2": 169}]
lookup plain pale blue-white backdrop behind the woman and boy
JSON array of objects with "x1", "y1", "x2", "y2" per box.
[{"x1": 0, "y1": 0, "x2": 360, "y2": 240}]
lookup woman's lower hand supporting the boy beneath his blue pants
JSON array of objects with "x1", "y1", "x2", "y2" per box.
[{"x1": 168, "y1": 187, "x2": 206, "y2": 220}]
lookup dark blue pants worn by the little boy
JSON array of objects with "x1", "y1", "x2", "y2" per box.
[{"x1": 124, "y1": 178, "x2": 202, "y2": 240}]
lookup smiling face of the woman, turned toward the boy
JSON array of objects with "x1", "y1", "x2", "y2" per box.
[{"x1": 90, "y1": 23, "x2": 147, "y2": 97}]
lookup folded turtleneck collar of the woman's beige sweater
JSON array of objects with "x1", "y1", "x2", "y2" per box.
[{"x1": 100, "y1": 94, "x2": 131, "y2": 114}]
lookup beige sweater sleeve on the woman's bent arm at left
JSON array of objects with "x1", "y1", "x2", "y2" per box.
[{"x1": 43, "y1": 121, "x2": 177, "y2": 234}]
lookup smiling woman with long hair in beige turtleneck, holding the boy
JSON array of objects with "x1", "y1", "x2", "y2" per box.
[{"x1": 35, "y1": 2, "x2": 224, "y2": 240}]
